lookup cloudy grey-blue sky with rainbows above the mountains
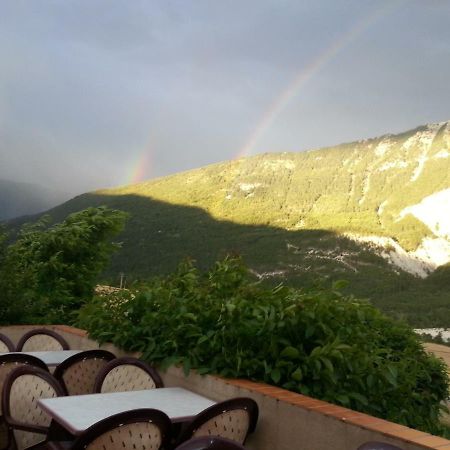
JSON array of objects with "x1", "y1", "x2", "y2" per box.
[{"x1": 0, "y1": 0, "x2": 450, "y2": 197}]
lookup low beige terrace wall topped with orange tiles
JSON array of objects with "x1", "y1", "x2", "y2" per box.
[{"x1": 0, "y1": 325, "x2": 450, "y2": 450}]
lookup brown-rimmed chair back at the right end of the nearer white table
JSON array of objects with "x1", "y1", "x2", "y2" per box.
[{"x1": 179, "y1": 397, "x2": 258, "y2": 444}]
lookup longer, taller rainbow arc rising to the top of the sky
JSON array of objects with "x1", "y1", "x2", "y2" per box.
[{"x1": 234, "y1": 0, "x2": 408, "y2": 159}]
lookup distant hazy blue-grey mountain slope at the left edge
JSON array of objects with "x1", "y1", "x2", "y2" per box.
[{"x1": 0, "y1": 179, "x2": 66, "y2": 220}]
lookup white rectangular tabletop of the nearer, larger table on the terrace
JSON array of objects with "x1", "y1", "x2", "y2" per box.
[{"x1": 38, "y1": 388, "x2": 215, "y2": 435}]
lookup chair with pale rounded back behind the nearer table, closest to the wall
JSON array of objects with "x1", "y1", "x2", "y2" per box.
[{"x1": 94, "y1": 356, "x2": 163, "y2": 393}]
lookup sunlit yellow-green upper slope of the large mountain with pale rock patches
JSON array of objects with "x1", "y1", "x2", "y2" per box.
[{"x1": 92, "y1": 122, "x2": 450, "y2": 275}]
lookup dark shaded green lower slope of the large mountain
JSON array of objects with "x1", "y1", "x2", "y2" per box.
[{"x1": 7, "y1": 193, "x2": 450, "y2": 323}]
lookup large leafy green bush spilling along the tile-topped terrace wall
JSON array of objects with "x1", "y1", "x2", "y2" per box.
[{"x1": 79, "y1": 258, "x2": 448, "y2": 432}]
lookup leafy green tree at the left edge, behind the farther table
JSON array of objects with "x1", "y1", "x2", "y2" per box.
[{"x1": 0, "y1": 207, "x2": 126, "y2": 324}]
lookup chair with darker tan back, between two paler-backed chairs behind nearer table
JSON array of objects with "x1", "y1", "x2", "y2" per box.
[{"x1": 53, "y1": 350, "x2": 115, "y2": 395}]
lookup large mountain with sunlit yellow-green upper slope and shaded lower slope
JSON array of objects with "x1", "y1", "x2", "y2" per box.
[{"x1": 8, "y1": 122, "x2": 450, "y2": 326}]
